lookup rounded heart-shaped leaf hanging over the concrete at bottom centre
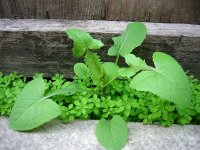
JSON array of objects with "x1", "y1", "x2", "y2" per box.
[{"x1": 96, "y1": 115, "x2": 128, "y2": 150}]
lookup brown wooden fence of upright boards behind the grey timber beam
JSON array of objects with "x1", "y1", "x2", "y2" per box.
[{"x1": 0, "y1": 0, "x2": 200, "y2": 24}]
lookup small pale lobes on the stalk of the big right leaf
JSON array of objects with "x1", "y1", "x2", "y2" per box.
[{"x1": 118, "y1": 54, "x2": 147, "y2": 78}]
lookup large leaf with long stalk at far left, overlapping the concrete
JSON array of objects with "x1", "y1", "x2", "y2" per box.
[{"x1": 9, "y1": 77, "x2": 77, "y2": 131}]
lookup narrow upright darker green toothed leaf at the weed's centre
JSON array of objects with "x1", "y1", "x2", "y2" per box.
[{"x1": 85, "y1": 51, "x2": 102, "y2": 86}]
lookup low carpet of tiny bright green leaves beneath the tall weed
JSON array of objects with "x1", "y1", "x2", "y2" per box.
[{"x1": 0, "y1": 73, "x2": 200, "y2": 126}]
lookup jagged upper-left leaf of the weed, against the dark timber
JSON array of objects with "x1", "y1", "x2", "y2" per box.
[{"x1": 65, "y1": 29, "x2": 104, "y2": 57}]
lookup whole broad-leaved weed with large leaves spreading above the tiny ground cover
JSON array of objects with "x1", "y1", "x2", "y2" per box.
[{"x1": 7, "y1": 22, "x2": 191, "y2": 150}]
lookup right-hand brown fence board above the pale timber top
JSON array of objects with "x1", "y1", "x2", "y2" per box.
[{"x1": 106, "y1": 0, "x2": 200, "y2": 24}]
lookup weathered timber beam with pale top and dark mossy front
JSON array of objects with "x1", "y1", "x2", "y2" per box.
[{"x1": 0, "y1": 19, "x2": 200, "y2": 79}]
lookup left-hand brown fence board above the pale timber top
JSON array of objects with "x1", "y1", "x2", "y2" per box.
[{"x1": 0, "y1": 0, "x2": 105, "y2": 19}]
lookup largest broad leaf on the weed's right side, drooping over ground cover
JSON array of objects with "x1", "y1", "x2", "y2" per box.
[{"x1": 130, "y1": 52, "x2": 191, "y2": 108}]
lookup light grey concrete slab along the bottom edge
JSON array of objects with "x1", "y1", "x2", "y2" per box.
[{"x1": 0, "y1": 117, "x2": 200, "y2": 150}]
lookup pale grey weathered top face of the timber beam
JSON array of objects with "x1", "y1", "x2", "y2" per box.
[{"x1": 0, "y1": 19, "x2": 200, "y2": 37}]
